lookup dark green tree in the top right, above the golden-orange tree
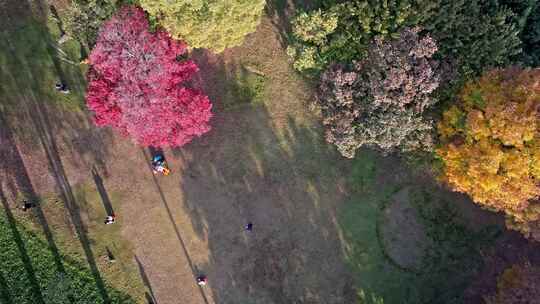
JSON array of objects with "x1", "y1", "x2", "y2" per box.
[{"x1": 422, "y1": 0, "x2": 521, "y2": 76}]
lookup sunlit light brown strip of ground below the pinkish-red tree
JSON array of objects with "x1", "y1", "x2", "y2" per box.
[{"x1": 94, "y1": 138, "x2": 215, "y2": 304}]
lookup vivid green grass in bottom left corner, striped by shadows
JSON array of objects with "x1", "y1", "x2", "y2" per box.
[{"x1": 0, "y1": 205, "x2": 135, "y2": 304}]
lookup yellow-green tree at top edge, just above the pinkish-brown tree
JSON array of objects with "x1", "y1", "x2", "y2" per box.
[{"x1": 287, "y1": 0, "x2": 436, "y2": 73}]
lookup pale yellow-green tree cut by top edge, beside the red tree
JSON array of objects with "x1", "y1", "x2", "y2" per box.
[{"x1": 140, "y1": 0, "x2": 265, "y2": 53}]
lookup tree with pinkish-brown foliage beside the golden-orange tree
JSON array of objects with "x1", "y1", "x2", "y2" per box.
[{"x1": 317, "y1": 28, "x2": 440, "y2": 158}]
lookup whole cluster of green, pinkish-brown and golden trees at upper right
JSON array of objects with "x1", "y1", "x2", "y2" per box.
[{"x1": 287, "y1": 0, "x2": 540, "y2": 239}]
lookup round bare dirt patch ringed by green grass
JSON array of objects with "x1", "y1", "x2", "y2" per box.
[{"x1": 379, "y1": 188, "x2": 431, "y2": 272}]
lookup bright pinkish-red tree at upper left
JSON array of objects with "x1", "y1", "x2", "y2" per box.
[{"x1": 86, "y1": 6, "x2": 212, "y2": 146}]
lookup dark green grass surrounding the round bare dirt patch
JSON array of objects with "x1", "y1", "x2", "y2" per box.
[{"x1": 338, "y1": 151, "x2": 496, "y2": 304}]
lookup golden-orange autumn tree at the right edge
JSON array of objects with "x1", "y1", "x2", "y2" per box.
[{"x1": 437, "y1": 68, "x2": 540, "y2": 239}]
